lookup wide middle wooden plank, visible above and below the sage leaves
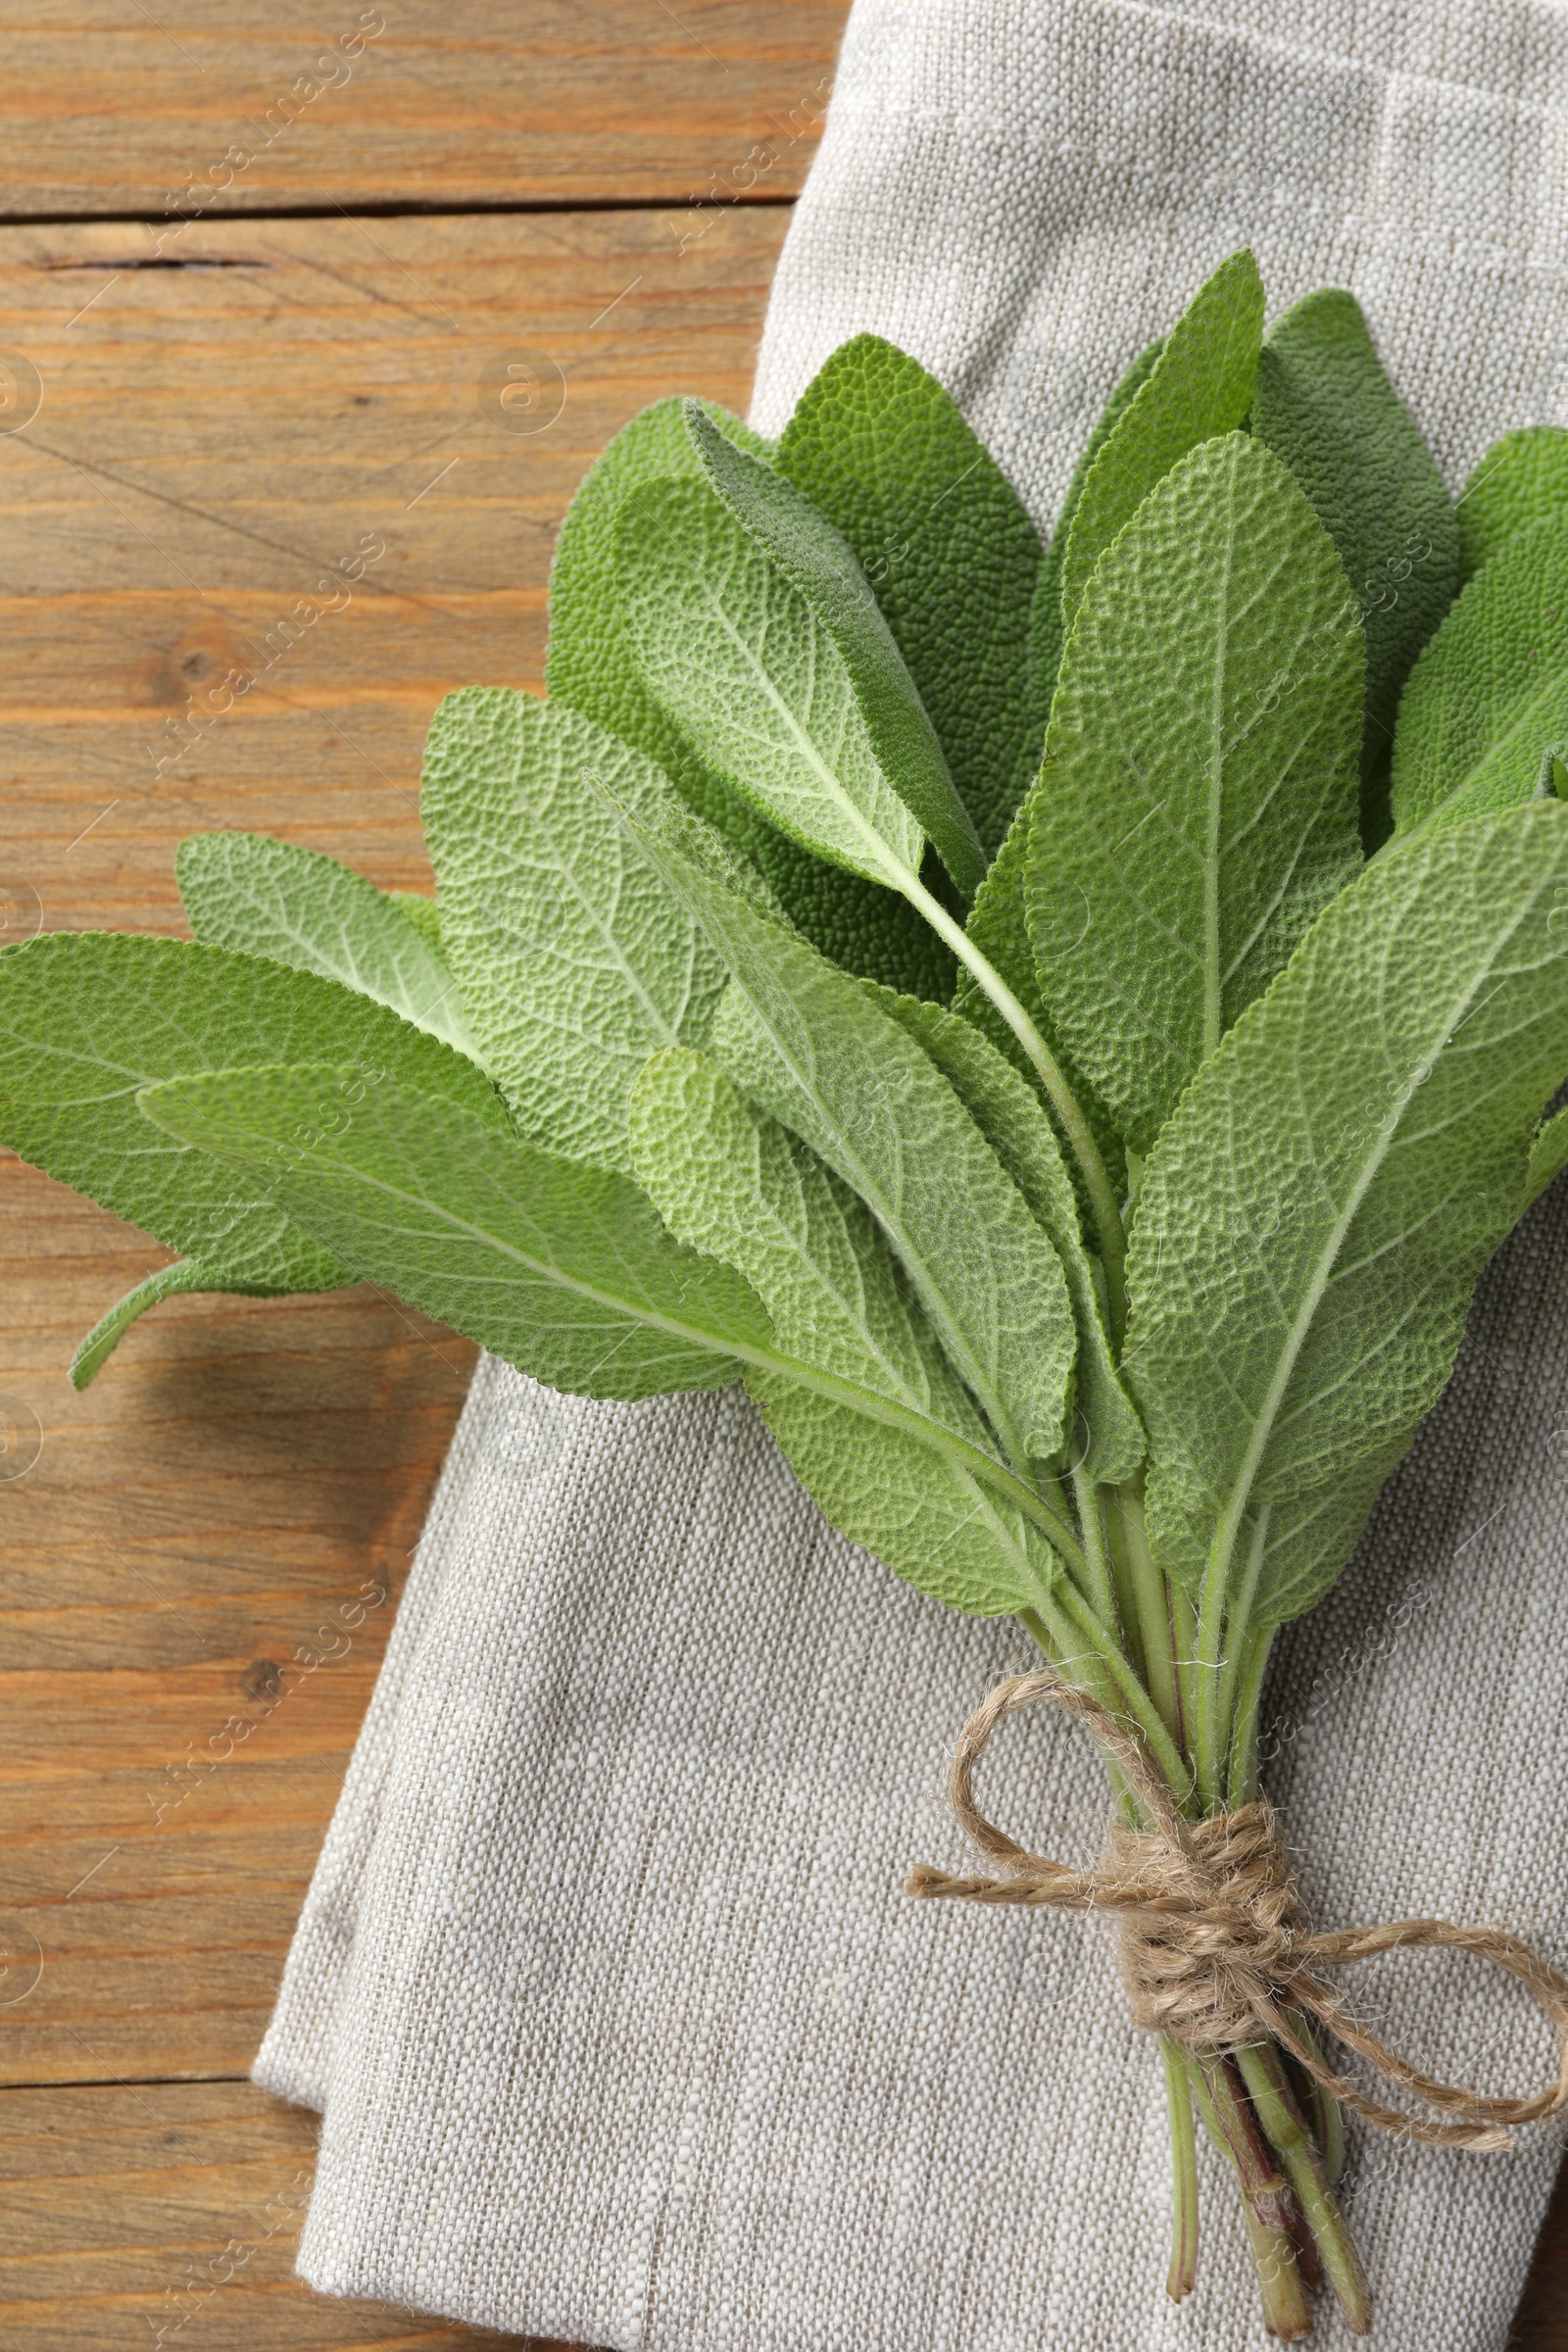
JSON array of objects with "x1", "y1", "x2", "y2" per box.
[{"x1": 0, "y1": 212, "x2": 780, "y2": 2082}]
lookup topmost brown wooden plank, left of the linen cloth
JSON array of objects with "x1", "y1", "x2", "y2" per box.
[{"x1": 0, "y1": 0, "x2": 849, "y2": 216}]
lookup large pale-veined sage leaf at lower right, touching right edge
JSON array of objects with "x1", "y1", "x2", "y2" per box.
[{"x1": 1124, "y1": 802, "x2": 1568, "y2": 1623}]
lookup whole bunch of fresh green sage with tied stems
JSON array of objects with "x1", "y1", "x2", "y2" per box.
[{"x1": 0, "y1": 252, "x2": 1568, "y2": 2335}]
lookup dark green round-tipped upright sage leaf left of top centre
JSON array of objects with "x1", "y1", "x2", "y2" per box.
[{"x1": 776, "y1": 334, "x2": 1044, "y2": 860}]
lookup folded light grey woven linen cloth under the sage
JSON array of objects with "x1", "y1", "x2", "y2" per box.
[{"x1": 256, "y1": 0, "x2": 1568, "y2": 2352}]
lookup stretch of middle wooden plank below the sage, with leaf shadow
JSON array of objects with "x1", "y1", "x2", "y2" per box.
[{"x1": 0, "y1": 1159, "x2": 472, "y2": 2082}]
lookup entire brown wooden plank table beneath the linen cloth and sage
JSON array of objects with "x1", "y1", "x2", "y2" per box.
[{"x1": 0, "y1": 0, "x2": 1568, "y2": 2352}]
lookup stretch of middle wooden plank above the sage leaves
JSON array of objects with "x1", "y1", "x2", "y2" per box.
[{"x1": 0, "y1": 210, "x2": 785, "y2": 927}]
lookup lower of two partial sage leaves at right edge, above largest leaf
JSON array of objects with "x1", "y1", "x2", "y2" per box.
[{"x1": 1394, "y1": 513, "x2": 1568, "y2": 833}]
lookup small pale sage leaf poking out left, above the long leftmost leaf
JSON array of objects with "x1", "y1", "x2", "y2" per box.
[{"x1": 174, "y1": 833, "x2": 479, "y2": 1060}]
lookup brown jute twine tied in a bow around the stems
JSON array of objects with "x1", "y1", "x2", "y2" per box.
[{"x1": 906, "y1": 1672, "x2": 1568, "y2": 2147}]
